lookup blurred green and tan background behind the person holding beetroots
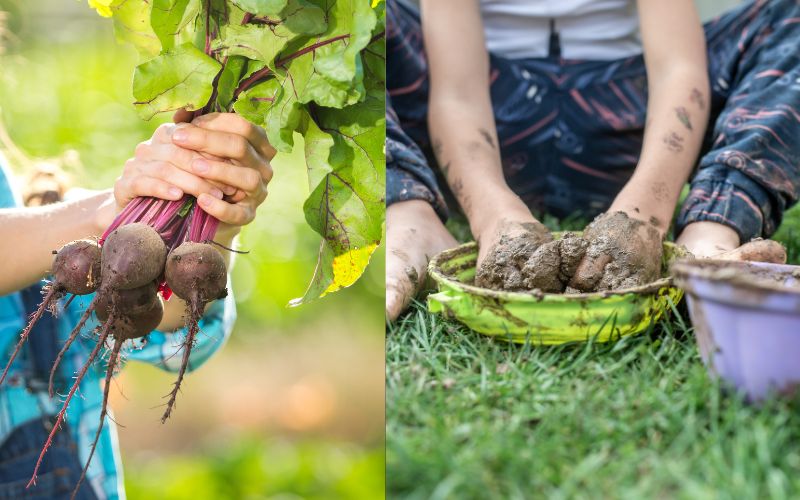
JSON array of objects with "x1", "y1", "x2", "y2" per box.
[{"x1": 0, "y1": 0, "x2": 384, "y2": 500}]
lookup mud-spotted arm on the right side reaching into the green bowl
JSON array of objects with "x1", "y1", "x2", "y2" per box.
[{"x1": 573, "y1": 0, "x2": 710, "y2": 289}]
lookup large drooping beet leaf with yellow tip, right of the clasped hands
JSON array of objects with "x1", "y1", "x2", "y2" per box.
[{"x1": 291, "y1": 88, "x2": 386, "y2": 305}]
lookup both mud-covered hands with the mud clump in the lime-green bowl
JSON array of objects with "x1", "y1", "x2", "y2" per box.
[{"x1": 475, "y1": 212, "x2": 662, "y2": 294}]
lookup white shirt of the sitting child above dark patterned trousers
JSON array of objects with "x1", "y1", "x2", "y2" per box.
[{"x1": 480, "y1": 0, "x2": 642, "y2": 60}]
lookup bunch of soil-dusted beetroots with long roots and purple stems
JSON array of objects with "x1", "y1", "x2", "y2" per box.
[{"x1": 0, "y1": 196, "x2": 227, "y2": 496}]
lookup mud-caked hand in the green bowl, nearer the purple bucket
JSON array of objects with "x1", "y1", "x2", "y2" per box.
[{"x1": 570, "y1": 212, "x2": 663, "y2": 292}]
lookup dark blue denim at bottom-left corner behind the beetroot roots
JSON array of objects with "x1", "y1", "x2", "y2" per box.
[{"x1": 0, "y1": 417, "x2": 97, "y2": 500}]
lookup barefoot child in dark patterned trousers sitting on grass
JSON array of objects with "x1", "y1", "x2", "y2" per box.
[{"x1": 386, "y1": 0, "x2": 800, "y2": 320}]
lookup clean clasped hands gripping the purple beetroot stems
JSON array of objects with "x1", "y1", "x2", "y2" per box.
[{"x1": 108, "y1": 112, "x2": 275, "y2": 238}]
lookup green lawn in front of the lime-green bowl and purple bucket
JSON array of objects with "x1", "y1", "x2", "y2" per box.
[{"x1": 386, "y1": 205, "x2": 800, "y2": 499}]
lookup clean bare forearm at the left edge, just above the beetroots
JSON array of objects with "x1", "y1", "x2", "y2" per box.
[{"x1": 0, "y1": 191, "x2": 113, "y2": 295}]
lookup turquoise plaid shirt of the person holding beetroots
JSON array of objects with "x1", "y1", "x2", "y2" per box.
[{"x1": 0, "y1": 161, "x2": 236, "y2": 500}]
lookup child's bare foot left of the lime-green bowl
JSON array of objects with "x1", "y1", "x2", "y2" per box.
[{"x1": 386, "y1": 200, "x2": 458, "y2": 321}]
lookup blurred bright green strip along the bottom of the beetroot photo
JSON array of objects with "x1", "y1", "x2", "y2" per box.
[{"x1": 127, "y1": 436, "x2": 384, "y2": 500}]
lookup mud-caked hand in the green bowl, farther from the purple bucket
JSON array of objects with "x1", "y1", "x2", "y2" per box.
[{"x1": 475, "y1": 217, "x2": 553, "y2": 290}]
